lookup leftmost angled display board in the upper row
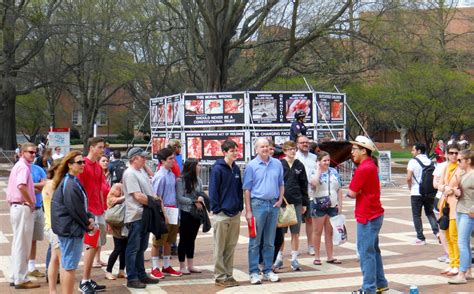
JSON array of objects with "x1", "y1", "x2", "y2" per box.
[{"x1": 150, "y1": 94, "x2": 182, "y2": 129}]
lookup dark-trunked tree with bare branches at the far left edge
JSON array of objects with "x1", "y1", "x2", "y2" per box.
[{"x1": 0, "y1": 0, "x2": 61, "y2": 149}]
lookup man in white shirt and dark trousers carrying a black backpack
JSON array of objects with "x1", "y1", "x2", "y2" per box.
[{"x1": 407, "y1": 143, "x2": 439, "y2": 245}]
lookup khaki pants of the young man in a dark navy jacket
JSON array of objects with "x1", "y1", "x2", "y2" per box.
[{"x1": 214, "y1": 212, "x2": 240, "y2": 281}]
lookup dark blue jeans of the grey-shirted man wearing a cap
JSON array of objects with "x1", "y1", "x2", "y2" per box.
[{"x1": 125, "y1": 220, "x2": 150, "y2": 281}]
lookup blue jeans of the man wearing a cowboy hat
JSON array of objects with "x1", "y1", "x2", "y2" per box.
[{"x1": 357, "y1": 215, "x2": 388, "y2": 293}]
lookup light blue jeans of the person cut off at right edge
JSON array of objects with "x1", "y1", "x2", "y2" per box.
[{"x1": 456, "y1": 212, "x2": 474, "y2": 272}]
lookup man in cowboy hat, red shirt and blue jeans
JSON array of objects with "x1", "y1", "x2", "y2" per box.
[{"x1": 347, "y1": 136, "x2": 388, "y2": 294}]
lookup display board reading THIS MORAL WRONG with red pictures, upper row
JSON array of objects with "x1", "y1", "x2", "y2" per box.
[{"x1": 183, "y1": 92, "x2": 245, "y2": 127}]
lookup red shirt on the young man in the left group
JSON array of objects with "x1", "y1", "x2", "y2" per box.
[{"x1": 78, "y1": 157, "x2": 107, "y2": 215}]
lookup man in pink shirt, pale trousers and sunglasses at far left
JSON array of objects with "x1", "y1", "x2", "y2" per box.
[{"x1": 6, "y1": 142, "x2": 40, "y2": 289}]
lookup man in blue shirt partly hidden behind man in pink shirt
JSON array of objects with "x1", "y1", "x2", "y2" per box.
[{"x1": 28, "y1": 164, "x2": 46, "y2": 278}]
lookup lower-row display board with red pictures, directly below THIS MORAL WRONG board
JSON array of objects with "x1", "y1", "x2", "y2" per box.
[{"x1": 184, "y1": 131, "x2": 247, "y2": 163}]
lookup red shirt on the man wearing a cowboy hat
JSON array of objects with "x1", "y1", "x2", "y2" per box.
[{"x1": 349, "y1": 158, "x2": 384, "y2": 224}]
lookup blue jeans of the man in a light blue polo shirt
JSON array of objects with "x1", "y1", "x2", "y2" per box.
[{"x1": 248, "y1": 198, "x2": 279, "y2": 274}]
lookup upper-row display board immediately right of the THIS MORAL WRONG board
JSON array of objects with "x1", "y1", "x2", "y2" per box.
[{"x1": 248, "y1": 92, "x2": 313, "y2": 126}]
